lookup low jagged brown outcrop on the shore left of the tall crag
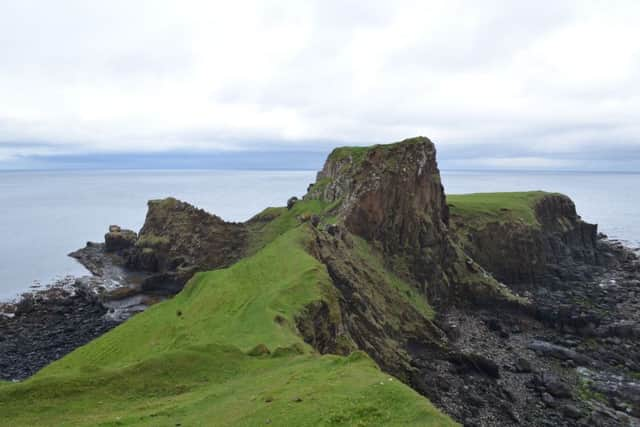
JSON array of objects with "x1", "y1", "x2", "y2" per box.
[{"x1": 70, "y1": 198, "x2": 248, "y2": 295}]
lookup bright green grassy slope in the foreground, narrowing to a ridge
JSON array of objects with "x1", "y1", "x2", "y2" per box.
[{"x1": 0, "y1": 226, "x2": 453, "y2": 426}]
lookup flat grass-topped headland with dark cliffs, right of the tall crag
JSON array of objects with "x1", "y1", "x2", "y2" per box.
[{"x1": 448, "y1": 191, "x2": 604, "y2": 288}]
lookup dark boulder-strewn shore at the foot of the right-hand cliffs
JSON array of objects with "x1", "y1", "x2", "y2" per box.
[{"x1": 414, "y1": 240, "x2": 640, "y2": 427}]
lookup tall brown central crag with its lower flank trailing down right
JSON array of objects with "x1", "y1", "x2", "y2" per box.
[{"x1": 305, "y1": 137, "x2": 512, "y2": 303}]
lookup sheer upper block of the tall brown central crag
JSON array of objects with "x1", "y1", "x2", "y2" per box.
[{"x1": 308, "y1": 137, "x2": 448, "y2": 252}]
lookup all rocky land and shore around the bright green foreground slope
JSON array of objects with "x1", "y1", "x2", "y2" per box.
[{"x1": 0, "y1": 137, "x2": 640, "y2": 426}]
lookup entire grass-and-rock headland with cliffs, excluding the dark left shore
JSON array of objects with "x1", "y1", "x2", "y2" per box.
[{"x1": 0, "y1": 137, "x2": 640, "y2": 426}]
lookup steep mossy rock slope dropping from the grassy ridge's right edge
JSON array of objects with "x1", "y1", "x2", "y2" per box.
[{"x1": 298, "y1": 229, "x2": 446, "y2": 382}]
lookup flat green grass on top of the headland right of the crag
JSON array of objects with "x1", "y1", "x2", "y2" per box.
[{"x1": 447, "y1": 191, "x2": 550, "y2": 227}]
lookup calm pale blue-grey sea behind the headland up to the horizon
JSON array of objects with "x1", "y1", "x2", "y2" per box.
[{"x1": 0, "y1": 170, "x2": 640, "y2": 300}]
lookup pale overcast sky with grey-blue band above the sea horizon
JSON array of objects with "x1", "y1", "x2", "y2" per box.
[{"x1": 0, "y1": 0, "x2": 640, "y2": 171}]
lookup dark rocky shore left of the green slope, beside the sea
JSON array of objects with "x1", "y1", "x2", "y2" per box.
[{"x1": 0, "y1": 231, "x2": 171, "y2": 381}]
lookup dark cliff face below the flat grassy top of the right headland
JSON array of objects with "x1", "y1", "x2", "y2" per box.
[{"x1": 451, "y1": 193, "x2": 603, "y2": 285}]
